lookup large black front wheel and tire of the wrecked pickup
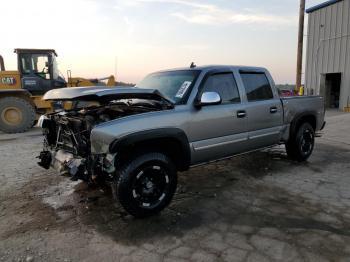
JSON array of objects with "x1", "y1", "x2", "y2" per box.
[{"x1": 117, "y1": 152, "x2": 177, "y2": 218}]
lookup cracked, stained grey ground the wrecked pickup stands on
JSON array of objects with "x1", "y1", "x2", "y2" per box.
[{"x1": 0, "y1": 113, "x2": 350, "y2": 262}]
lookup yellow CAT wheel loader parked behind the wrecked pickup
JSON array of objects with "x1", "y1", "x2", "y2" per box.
[{"x1": 0, "y1": 49, "x2": 115, "y2": 133}]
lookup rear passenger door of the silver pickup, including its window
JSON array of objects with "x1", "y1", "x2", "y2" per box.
[{"x1": 239, "y1": 71, "x2": 283, "y2": 149}]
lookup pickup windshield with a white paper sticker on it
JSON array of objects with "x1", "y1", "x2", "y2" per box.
[{"x1": 136, "y1": 70, "x2": 200, "y2": 104}]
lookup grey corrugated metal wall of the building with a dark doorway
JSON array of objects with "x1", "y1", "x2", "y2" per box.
[{"x1": 305, "y1": 0, "x2": 350, "y2": 109}]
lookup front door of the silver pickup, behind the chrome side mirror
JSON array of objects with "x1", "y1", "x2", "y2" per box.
[{"x1": 189, "y1": 72, "x2": 248, "y2": 164}]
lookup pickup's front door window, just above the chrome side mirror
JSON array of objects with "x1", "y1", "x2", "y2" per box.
[{"x1": 202, "y1": 73, "x2": 241, "y2": 103}]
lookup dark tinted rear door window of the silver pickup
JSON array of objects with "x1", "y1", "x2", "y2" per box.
[{"x1": 241, "y1": 73, "x2": 273, "y2": 101}]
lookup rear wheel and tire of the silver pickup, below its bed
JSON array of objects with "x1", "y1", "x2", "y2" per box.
[{"x1": 286, "y1": 122, "x2": 315, "y2": 162}]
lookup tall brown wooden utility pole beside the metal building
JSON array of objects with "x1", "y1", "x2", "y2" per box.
[{"x1": 295, "y1": 0, "x2": 305, "y2": 93}]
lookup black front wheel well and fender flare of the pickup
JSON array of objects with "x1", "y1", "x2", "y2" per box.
[{"x1": 117, "y1": 138, "x2": 190, "y2": 171}]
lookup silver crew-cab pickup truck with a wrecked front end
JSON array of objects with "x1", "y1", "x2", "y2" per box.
[{"x1": 39, "y1": 66, "x2": 325, "y2": 217}]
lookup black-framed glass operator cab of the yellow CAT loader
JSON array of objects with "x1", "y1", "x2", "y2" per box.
[{"x1": 15, "y1": 49, "x2": 66, "y2": 95}]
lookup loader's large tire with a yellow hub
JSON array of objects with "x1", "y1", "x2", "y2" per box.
[{"x1": 0, "y1": 96, "x2": 35, "y2": 134}]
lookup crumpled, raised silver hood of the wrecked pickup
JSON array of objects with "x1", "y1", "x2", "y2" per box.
[{"x1": 43, "y1": 86, "x2": 173, "y2": 104}]
